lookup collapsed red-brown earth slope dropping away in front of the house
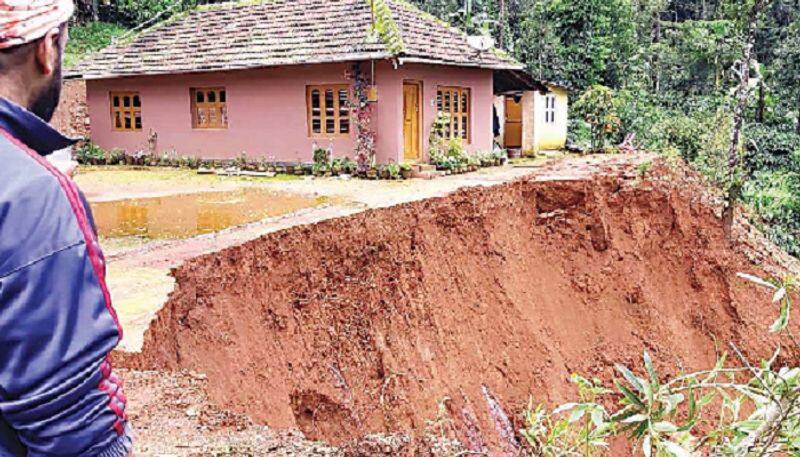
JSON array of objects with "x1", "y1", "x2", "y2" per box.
[{"x1": 134, "y1": 159, "x2": 792, "y2": 448}]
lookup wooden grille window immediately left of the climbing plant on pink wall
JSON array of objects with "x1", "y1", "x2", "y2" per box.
[{"x1": 306, "y1": 84, "x2": 350, "y2": 138}]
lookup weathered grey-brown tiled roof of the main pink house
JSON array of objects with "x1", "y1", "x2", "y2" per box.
[{"x1": 67, "y1": 0, "x2": 520, "y2": 79}]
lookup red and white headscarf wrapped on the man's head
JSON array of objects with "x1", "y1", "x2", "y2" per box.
[{"x1": 0, "y1": 0, "x2": 75, "y2": 49}]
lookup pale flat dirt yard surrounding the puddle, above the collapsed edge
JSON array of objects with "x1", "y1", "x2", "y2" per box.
[{"x1": 76, "y1": 158, "x2": 560, "y2": 351}]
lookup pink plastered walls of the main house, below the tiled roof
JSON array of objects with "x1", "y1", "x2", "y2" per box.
[{"x1": 87, "y1": 62, "x2": 492, "y2": 162}]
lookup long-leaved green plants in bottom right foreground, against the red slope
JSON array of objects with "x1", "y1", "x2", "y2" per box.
[{"x1": 521, "y1": 273, "x2": 800, "y2": 457}]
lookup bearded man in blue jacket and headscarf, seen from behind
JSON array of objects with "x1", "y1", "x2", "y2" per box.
[{"x1": 0, "y1": 0, "x2": 131, "y2": 457}]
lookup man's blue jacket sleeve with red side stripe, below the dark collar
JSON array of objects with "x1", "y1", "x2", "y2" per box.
[{"x1": 0, "y1": 141, "x2": 131, "y2": 457}]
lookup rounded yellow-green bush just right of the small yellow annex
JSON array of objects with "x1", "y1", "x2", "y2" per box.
[{"x1": 573, "y1": 85, "x2": 621, "y2": 151}]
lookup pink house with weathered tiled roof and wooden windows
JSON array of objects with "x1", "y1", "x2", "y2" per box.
[{"x1": 67, "y1": 0, "x2": 522, "y2": 162}]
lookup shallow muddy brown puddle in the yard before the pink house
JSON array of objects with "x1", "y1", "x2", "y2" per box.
[{"x1": 91, "y1": 188, "x2": 327, "y2": 240}]
